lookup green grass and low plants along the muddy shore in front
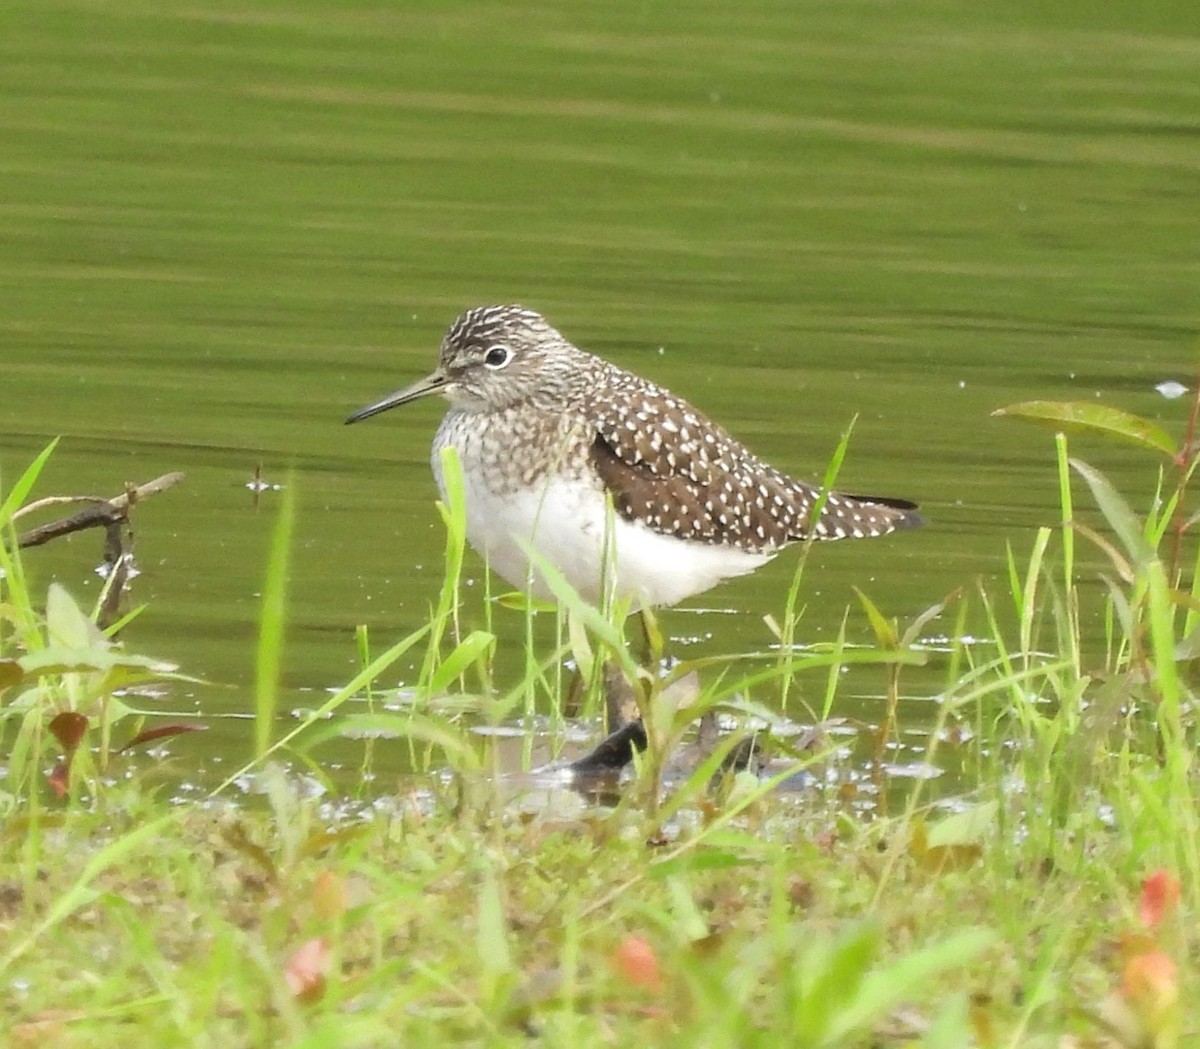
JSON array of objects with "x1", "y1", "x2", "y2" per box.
[{"x1": 0, "y1": 398, "x2": 1200, "y2": 1049}]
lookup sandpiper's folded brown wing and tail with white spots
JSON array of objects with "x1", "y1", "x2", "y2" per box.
[{"x1": 590, "y1": 368, "x2": 920, "y2": 551}]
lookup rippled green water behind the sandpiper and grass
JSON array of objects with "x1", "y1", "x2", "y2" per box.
[{"x1": 0, "y1": 0, "x2": 1200, "y2": 787}]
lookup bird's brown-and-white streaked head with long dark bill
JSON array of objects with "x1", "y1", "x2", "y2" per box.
[{"x1": 346, "y1": 306, "x2": 578, "y2": 422}]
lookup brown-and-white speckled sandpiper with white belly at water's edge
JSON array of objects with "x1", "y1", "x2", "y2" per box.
[{"x1": 346, "y1": 305, "x2": 923, "y2": 610}]
